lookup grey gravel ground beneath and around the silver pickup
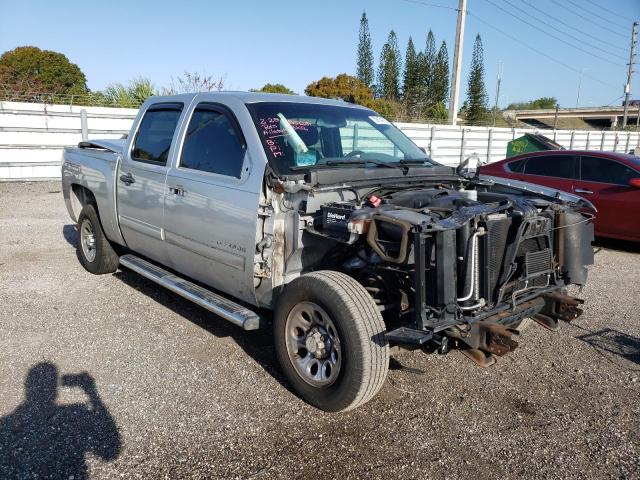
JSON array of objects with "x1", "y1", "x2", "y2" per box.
[{"x1": 0, "y1": 182, "x2": 640, "y2": 479}]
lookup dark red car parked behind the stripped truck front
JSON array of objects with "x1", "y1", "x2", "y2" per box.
[{"x1": 480, "y1": 150, "x2": 640, "y2": 242}]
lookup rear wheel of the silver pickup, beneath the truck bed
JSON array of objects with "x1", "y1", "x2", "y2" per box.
[{"x1": 77, "y1": 204, "x2": 119, "y2": 275}]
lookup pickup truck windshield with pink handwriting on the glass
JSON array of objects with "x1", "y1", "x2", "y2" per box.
[{"x1": 247, "y1": 102, "x2": 435, "y2": 175}]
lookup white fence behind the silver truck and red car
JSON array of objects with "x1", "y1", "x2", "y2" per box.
[{"x1": 0, "y1": 102, "x2": 640, "y2": 180}]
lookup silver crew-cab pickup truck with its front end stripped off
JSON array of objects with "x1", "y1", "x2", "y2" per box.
[{"x1": 62, "y1": 92, "x2": 595, "y2": 411}]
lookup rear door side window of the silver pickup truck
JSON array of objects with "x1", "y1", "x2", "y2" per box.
[{"x1": 131, "y1": 103, "x2": 182, "y2": 165}]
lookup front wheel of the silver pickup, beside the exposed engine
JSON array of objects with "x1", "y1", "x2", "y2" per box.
[{"x1": 274, "y1": 271, "x2": 389, "y2": 412}]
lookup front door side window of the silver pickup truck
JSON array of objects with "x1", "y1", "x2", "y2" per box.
[{"x1": 180, "y1": 104, "x2": 245, "y2": 178}]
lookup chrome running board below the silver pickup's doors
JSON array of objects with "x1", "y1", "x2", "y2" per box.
[{"x1": 120, "y1": 254, "x2": 260, "y2": 330}]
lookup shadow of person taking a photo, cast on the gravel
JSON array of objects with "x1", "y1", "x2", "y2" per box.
[{"x1": 0, "y1": 362, "x2": 122, "y2": 480}]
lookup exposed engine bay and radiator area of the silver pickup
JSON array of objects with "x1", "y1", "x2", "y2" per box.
[{"x1": 256, "y1": 174, "x2": 593, "y2": 363}]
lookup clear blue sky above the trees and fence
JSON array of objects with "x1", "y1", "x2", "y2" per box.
[{"x1": 0, "y1": 0, "x2": 640, "y2": 107}]
